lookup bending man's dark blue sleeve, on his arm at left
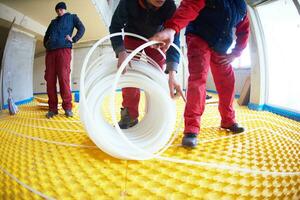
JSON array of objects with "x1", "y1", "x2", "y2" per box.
[{"x1": 109, "y1": 0, "x2": 128, "y2": 55}]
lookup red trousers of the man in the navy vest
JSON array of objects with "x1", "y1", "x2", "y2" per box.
[{"x1": 184, "y1": 34, "x2": 235, "y2": 133}]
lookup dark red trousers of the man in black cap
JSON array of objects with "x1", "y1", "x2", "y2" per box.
[{"x1": 44, "y1": 48, "x2": 72, "y2": 112}]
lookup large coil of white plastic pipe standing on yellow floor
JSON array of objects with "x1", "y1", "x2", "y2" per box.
[{"x1": 79, "y1": 33, "x2": 182, "y2": 160}]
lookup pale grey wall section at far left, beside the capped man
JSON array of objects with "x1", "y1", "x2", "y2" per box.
[{"x1": 3, "y1": 29, "x2": 36, "y2": 104}]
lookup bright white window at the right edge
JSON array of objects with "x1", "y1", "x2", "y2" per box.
[{"x1": 257, "y1": 0, "x2": 300, "y2": 113}]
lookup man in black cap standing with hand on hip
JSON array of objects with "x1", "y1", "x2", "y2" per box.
[{"x1": 44, "y1": 2, "x2": 85, "y2": 118}]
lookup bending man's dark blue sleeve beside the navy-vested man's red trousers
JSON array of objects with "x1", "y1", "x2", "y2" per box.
[{"x1": 166, "y1": 33, "x2": 180, "y2": 73}]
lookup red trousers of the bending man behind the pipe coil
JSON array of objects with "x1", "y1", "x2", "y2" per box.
[{"x1": 122, "y1": 37, "x2": 165, "y2": 119}]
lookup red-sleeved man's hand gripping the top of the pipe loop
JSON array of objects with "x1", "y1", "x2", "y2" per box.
[{"x1": 149, "y1": 28, "x2": 176, "y2": 52}]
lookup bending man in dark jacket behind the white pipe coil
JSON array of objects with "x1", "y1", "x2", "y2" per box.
[{"x1": 109, "y1": 0, "x2": 183, "y2": 129}]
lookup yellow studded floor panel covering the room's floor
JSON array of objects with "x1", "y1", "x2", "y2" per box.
[{"x1": 0, "y1": 96, "x2": 300, "y2": 200}]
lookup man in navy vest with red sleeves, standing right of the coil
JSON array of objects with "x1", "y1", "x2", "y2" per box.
[{"x1": 151, "y1": 0, "x2": 250, "y2": 147}]
